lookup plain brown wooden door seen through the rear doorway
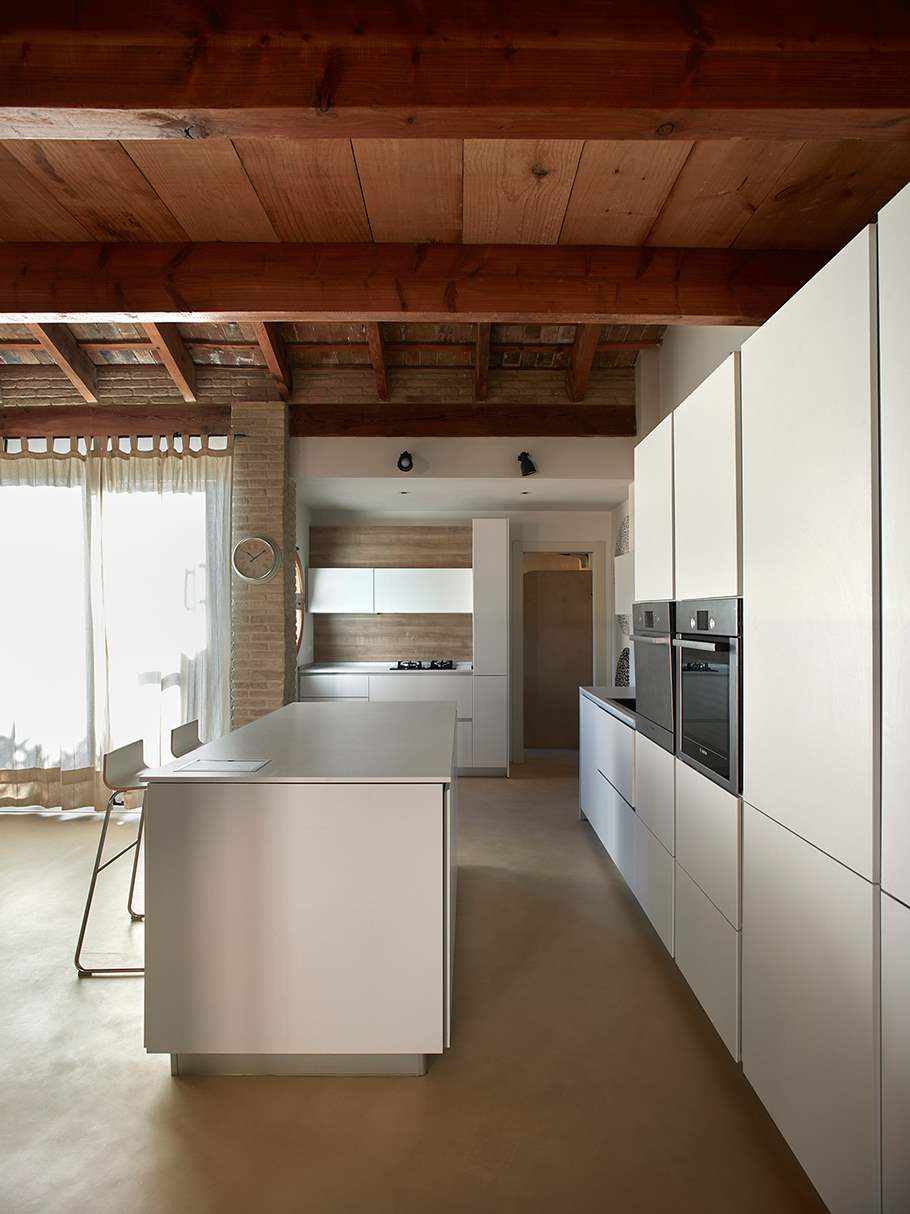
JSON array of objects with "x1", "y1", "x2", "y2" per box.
[{"x1": 524, "y1": 569, "x2": 593, "y2": 750}]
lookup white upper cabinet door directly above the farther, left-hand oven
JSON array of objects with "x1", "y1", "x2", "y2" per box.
[{"x1": 632, "y1": 414, "x2": 675, "y2": 602}]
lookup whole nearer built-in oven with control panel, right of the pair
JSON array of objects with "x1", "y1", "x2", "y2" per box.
[{"x1": 673, "y1": 599, "x2": 743, "y2": 795}]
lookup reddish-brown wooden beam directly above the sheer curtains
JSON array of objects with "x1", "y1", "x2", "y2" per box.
[{"x1": 0, "y1": 404, "x2": 231, "y2": 438}]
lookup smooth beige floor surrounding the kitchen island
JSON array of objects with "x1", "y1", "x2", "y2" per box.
[{"x1": 0, "y1": 759, "x2": 824, "y2": 1214}]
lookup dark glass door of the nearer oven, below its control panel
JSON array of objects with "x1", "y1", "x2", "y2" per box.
[{"x1": 673, "y1": 636, "x2": 740, "y2": 795}]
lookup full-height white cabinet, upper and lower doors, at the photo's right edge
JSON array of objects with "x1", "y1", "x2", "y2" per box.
[{"x1": 878, "y1": 188, "x2": 910, "y2": 1214}]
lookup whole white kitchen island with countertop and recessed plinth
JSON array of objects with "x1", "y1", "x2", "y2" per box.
[{"x1": 146, "y1": 703, "x2": 455, "y2": 1074}]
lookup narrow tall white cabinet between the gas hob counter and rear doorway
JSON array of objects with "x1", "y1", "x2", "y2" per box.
[{"x1": 473, "y1": 518, "x2": 511, "y2": 771}]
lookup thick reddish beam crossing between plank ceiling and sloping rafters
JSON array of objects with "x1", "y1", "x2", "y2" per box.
[{"x1": 0, "y1": 242, "x2": 829, "y2": 325}]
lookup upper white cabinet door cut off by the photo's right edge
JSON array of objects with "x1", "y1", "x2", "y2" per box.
[{"x1": 878, "y1": 177, "x2": 910, "y2": 903}]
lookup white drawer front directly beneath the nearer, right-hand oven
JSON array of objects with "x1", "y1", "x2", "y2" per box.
[{"x1": 676, "y1": 759, "x2": 743, "y2": 927}]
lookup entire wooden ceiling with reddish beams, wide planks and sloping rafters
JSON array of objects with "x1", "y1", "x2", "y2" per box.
[{"x1": 0, "y1": 0, "x2": 910, "y2": 433}]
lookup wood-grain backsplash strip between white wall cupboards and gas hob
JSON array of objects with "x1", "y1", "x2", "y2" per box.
[{"x1": 313, "y1": 616, "x2": 473, "y2": 662}]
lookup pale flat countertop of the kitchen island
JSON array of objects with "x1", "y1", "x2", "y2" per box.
[{"x1": 146, "y1": 700, "x2": 455, "y2": 784}]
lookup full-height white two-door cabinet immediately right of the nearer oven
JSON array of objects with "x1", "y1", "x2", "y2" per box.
[{"x1": 741, "y1": 228, "x2": 880, "y2": 1214}]
